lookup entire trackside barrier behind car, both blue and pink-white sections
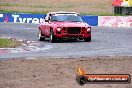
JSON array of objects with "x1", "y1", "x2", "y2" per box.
[{"x1": 0, "y1": 13, "x2": 132, "y2": 27}]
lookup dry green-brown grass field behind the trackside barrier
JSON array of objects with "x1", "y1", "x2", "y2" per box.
[{"x1": 0, "y1": 0, "x2": 128, "y2": 16}]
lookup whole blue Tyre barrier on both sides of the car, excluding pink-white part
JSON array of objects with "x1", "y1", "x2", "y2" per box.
[{"x1": 0, "y1": 13, "x2": 98, "y2": 26}]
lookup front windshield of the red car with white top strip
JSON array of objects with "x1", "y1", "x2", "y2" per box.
[{"x1": 51, "y1": 14, "x2": 82, "y2": 22}]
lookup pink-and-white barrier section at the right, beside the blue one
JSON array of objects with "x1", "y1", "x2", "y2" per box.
[{"x1": 98, "y1": 16, "x2": 132, "y2": 27}]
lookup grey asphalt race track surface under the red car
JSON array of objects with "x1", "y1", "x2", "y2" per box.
[{"x1": 0, "y1": 23, "x2": 132, "y2": 59}]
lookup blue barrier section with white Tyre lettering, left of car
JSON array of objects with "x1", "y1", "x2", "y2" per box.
[{"x1": 0, "y1": 13, "x2": 45, "y2": 23}]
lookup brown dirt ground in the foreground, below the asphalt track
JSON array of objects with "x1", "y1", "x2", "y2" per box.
[{"x1": 0, "y1": 57, "x2": 132, "y2": 88}]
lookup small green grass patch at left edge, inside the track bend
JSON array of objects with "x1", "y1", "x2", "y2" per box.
[{"x1": 0, "y1": 38, "x2": 20, "y2": 48}]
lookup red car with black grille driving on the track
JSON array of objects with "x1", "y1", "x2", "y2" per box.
[{"x1": 39, "y1": 12, "x2": 91, "y2": 43}]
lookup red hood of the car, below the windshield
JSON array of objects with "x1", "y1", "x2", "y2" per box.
[{"x1": 52, "y1": 22, "x2": 89, "y2": 27}]
